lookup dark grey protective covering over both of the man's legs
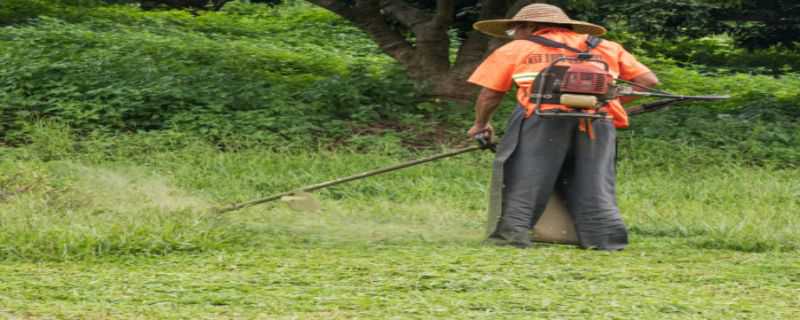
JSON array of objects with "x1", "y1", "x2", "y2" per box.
[{"x1": 487, "y1": 108, "x2": 628, "y2": 250}]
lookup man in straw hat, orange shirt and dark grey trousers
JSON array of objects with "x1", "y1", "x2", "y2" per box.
[{"x1": 468, "y1": 3, "x2": 658, "y2": 250}]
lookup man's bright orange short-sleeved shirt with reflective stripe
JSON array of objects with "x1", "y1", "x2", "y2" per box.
[{"x1": 468, "y1": 28, "x2": 650, "y2": 128}]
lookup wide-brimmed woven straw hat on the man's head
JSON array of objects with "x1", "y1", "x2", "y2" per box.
[{"x1": 473, "y1": 3, "x2": 606, "y2": 38}]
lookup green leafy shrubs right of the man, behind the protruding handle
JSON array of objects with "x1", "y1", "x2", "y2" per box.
[{"x1": 622, "y1": 59, "x2": 800, "y2": 167}]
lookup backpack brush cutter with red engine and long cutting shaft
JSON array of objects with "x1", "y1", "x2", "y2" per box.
[{"x1": 214, "y1": 79, "x2": 728, "y2": 244}]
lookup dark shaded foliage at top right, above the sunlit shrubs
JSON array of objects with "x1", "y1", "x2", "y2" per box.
[{"x1": 580, "y1": 0, "x2": 800, "y2": 49}]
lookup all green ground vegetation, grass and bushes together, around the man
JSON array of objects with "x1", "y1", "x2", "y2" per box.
[{"x1": 0, "y1": 0, "x2": 800, "y2": 319}]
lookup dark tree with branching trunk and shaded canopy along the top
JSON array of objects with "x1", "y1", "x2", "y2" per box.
[{"x1": 0, "y1": 0, "x2": 800, "y2": 100}]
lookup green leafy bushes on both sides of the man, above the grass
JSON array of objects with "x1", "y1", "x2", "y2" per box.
[{"x1": 0, "y1": 3, "x2": 800, "y2": 166}]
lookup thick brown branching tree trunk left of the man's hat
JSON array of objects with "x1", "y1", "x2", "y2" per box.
[{"x1": 310, "y1": 0, "x2": 544, "y2": 102}]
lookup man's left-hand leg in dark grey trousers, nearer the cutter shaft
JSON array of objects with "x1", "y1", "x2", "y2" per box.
[{"x1": 491, "y1": 116, "x2": 577, "y2": 247}]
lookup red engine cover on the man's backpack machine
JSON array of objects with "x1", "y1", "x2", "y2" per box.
[{"x1": 561, "y1": 63, "x2": 613, "y2": 95}]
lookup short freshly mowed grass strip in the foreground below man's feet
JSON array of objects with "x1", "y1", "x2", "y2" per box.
[{"x1": 0, "y1": 237, "x2": 800, "y2": 319}]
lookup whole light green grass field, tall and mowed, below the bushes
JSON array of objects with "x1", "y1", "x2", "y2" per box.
[{"x1": 0, "y1": 132, "x2": 800, "y2": 319}]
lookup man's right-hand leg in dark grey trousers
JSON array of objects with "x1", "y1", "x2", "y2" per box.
[{"x1": 559, "y1": 120, "x2": 628, "y2": 250}]
